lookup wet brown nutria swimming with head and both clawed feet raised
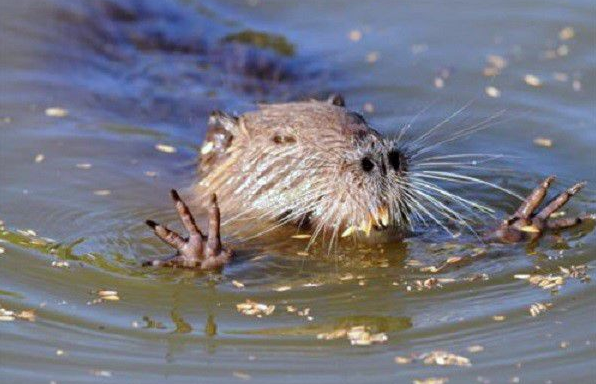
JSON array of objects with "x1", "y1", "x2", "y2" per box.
[{"x1": 147, "y1": 95, "x2": 593, "y2": 269}]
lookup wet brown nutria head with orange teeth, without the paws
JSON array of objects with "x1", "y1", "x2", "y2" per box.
[{"x1": 199, "y1": 97, "x2": 409, "y2": 241}]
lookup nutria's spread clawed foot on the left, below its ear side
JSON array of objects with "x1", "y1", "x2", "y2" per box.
[{"x1": 143, "y1": 189, "x2": 233, "y2": 269}]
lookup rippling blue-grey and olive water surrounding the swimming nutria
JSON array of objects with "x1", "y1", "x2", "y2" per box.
[{"x1": 0, "y1": 0, "x2": 596, "y2": 383}]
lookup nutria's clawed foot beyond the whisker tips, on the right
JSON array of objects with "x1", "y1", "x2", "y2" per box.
[{"x1": 487, "y1": 176, "x2": 595, "y2": 243}]
